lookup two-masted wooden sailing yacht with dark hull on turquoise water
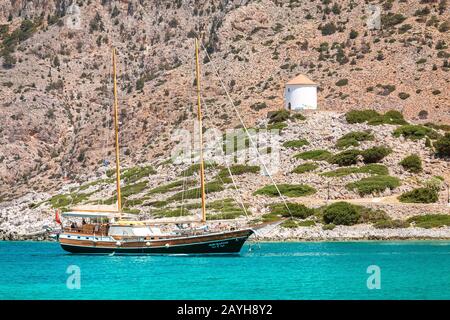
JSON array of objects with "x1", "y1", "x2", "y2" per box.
[{"x1": 56, "y1": 39, "x2": 254, "y2": 254}]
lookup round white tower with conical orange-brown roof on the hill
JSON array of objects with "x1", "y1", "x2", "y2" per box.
[{"x1": 284, "y1": 74, "x2": 317, "y2": 110}]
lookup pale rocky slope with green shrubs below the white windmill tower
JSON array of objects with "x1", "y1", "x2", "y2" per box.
[{"x1": 0, "y1": 112, "x2": 450, "y2": 237}]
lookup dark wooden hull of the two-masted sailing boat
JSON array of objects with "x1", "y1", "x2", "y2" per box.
[{"x1": 59, "y1": 229, "x2": 253, "y2": 254}]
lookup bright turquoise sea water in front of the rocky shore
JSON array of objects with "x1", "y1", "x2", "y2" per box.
[{"x1": 0, "y1": 241, "x2": 450, "y2": 299}]
